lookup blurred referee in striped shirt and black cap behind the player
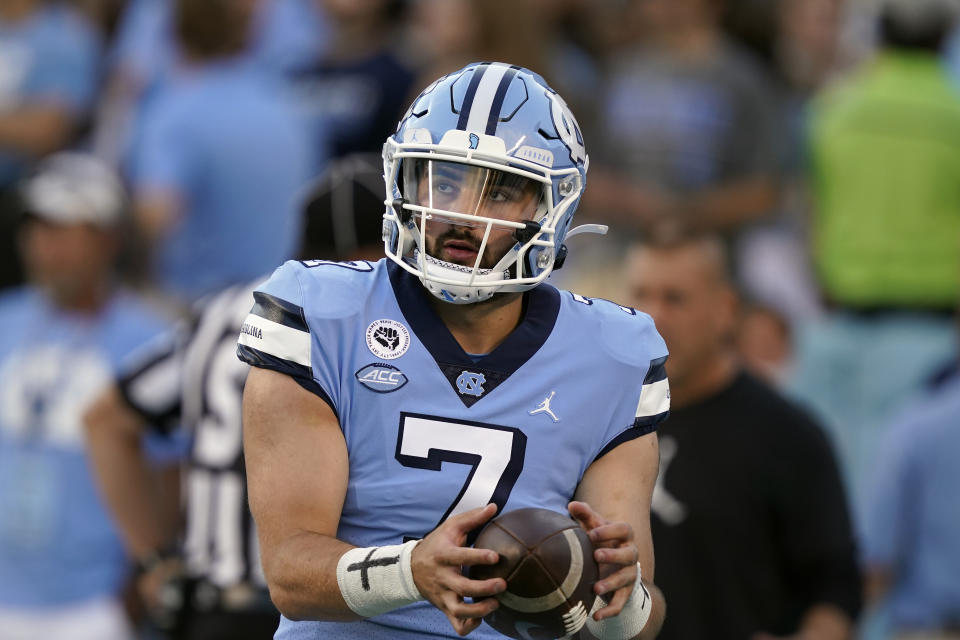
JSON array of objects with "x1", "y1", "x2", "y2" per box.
[{"x1": 85, "y1": 155, "x2": 383, "y2": 640}]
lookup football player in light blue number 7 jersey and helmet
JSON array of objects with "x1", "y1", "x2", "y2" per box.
[{"x1": 238, "y1": 63, "x2": 669, "y2": 640}]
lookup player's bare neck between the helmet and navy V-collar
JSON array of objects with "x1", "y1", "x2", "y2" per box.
[{"x1": 431, "y1": 293, "x2": 523, "y2": 354}]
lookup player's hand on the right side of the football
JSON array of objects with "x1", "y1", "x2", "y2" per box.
[{"x1": 567, "y1": 501, "x2": 640, "y2": 620}]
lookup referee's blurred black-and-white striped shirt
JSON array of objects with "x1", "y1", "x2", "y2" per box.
[{"x1": 119, "y1": 281, "x2": 266, "y2": 587}]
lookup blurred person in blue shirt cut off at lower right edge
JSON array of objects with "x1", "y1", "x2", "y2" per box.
[{"x1": 864, "y1": 362, "x2": 960, "y2": 639}]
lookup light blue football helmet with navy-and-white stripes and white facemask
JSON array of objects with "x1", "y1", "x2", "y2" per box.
[{"x1": 383, "y1": 62, "x2": 606, "y2": 304}]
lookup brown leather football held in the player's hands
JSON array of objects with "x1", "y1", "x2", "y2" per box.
[{"x1": 470, "y1": 509, "x2": 598, "y2": 640}]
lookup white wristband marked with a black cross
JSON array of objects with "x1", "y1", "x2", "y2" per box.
[{"x1": 337, "y1": 540, "x2": 423, "y2": 618}]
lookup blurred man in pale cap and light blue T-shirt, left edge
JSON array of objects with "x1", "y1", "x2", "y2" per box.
[{"x1": 0, "y1": 153, "x2": 172, "y2": 640}]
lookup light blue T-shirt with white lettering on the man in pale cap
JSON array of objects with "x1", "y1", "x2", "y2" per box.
[{"x1": 0, "y1": 290, "x2": 170, "y2": 609}]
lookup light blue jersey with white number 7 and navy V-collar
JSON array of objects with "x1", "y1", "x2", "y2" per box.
[{"x1": 239, "y1": 260, "x2": 669, "y2": 640}]
